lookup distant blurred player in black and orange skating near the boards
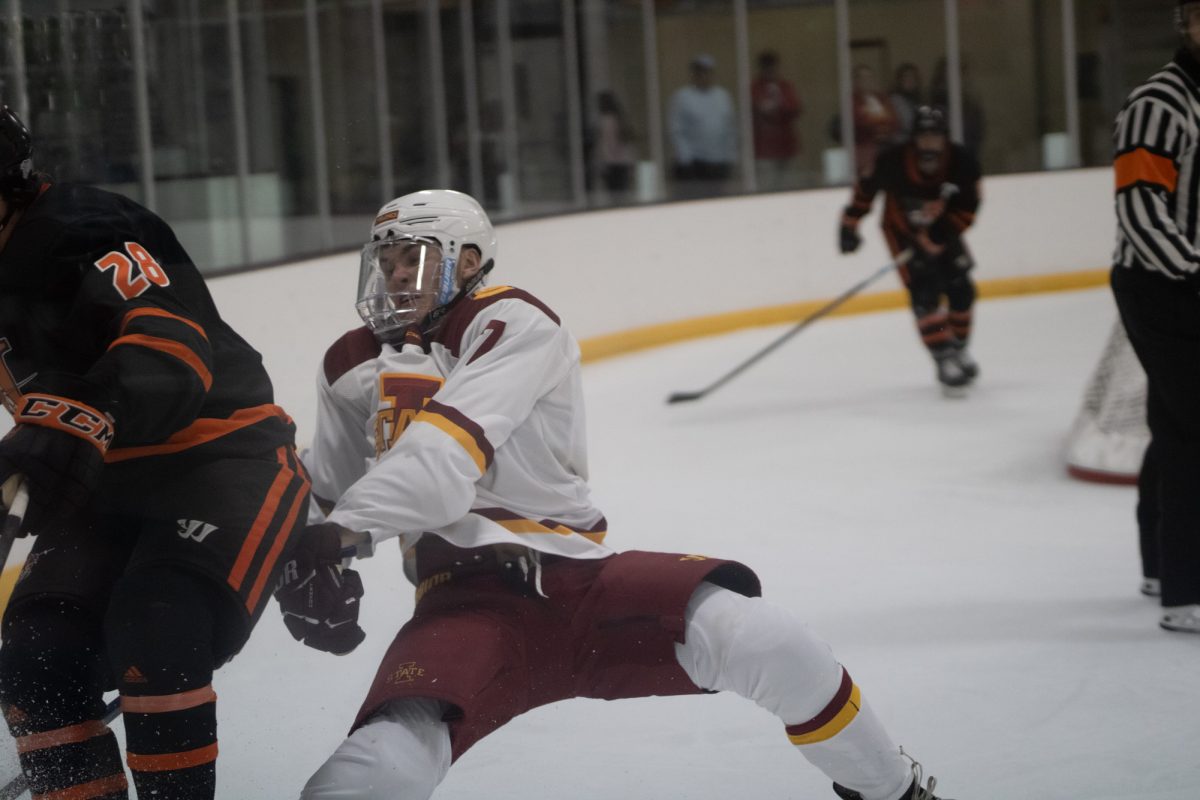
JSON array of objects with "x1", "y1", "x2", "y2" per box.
[{"x1": 839, "y1": 106, "x2": 980, "y2": 393}]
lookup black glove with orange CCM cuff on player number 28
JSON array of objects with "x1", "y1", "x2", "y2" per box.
[{"x1": 0, "y1": 392, "x2": 113, "y2": 535}]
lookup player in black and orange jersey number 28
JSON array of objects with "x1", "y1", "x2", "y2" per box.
[{"x1": 0, "y1": 107, "x2": 308, "y2": 800}]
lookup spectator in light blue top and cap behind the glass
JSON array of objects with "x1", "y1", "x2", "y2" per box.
[{"x1": 667, "y1": 55, "x2": 738, "y2": 198}]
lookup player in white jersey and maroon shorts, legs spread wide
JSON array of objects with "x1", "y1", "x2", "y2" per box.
[{"x1": 276, "y1": 191, "x2": 960, "y2": 800}]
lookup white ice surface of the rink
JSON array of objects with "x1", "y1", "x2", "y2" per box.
[{"x1": 7, "y1": 290, "x2": 1200, "y2": 800}]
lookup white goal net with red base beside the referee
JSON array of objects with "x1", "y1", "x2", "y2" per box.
[{"x1": 1067, "y1": 320, "x2": 1150, "y2": 483}]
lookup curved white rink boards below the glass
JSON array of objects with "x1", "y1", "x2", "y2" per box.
[{"x1": 211, "y1": 169, "x2": 1116, "y2": 444}]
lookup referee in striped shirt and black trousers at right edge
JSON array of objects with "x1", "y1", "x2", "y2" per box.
[{"x1": 1112, "y1": 0, "x2": 1200, "y2": 633}]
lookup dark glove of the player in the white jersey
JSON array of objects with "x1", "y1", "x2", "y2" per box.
[{"x1": 275, "y1": 522, "x2": 367, "y2": 656}]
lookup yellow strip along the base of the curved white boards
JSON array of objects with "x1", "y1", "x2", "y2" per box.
[{"x1": 580, "y1": 269, "x2": 1109, "y2": 362}]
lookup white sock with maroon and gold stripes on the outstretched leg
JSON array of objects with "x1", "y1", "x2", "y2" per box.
[{"x1": 676, "y1": 584, "x2": 912, "y2": 800}]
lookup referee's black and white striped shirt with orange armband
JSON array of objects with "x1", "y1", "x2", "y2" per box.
[{"x1": 1112, "y1": 49, "x2": 1200, "y2": 288}]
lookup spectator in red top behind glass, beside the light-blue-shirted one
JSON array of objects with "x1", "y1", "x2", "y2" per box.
[{"x1": 750, "y1": 50, "x2": 803, "y2": 191}]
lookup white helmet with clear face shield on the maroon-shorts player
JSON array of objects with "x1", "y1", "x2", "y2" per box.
[{"x1": 356, "y1": 190, "x2": 496, "y2": 341}]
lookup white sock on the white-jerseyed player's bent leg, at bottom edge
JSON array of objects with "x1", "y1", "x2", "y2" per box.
[{"x1": 300, "y1": 698, "x2": 450, "y2": 800}]
